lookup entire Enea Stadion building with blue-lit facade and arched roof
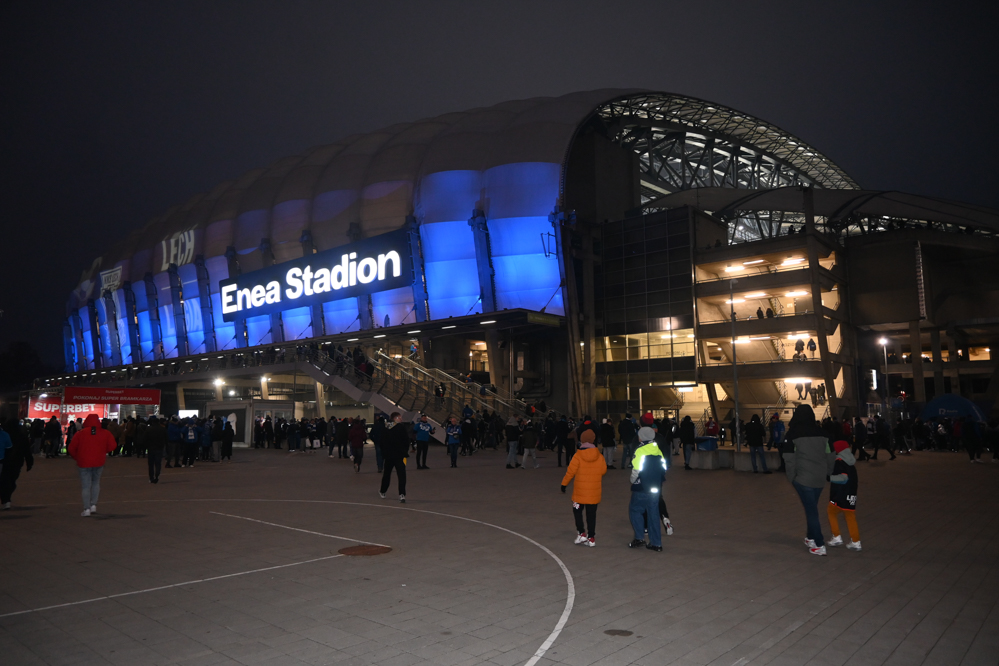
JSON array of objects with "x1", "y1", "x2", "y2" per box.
[{"x1": 32, "y1": 90, "x2": 999, "y2": 440}]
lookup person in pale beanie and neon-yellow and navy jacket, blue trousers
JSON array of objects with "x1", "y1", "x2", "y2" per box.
[{"x1": 628, "y1": 427, "x2": 666, "y2": 552}]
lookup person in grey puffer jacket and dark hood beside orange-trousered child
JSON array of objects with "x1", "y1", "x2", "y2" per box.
[{"x1": 783, "y1": 405, "x2": 836, "y2": 555}]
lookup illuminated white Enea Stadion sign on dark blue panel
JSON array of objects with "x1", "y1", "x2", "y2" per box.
[{"x1": 219, "y1": 229, "x2": 413, "y2": 321}]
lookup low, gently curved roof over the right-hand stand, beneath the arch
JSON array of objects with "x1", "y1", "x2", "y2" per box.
[{"x1": 646, "y1": 187, "x2": 999, "y2": 234}]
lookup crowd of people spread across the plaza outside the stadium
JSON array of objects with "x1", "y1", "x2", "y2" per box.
[{"x1": 0, "y1": 396, "x2": 999, "y2": 555}]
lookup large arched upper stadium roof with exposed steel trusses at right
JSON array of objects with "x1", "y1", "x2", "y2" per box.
[{"x1": 81, "y1": 89, "x2": 856, "y2": 284}]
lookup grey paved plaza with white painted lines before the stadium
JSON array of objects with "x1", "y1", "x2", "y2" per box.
[{"x1": 0, "y1": 440, "x2": 999, "y2": 666}]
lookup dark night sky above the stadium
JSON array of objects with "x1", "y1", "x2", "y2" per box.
[{"x1": 0, "y1": 0, "x2": 999, "y2": 365}]
